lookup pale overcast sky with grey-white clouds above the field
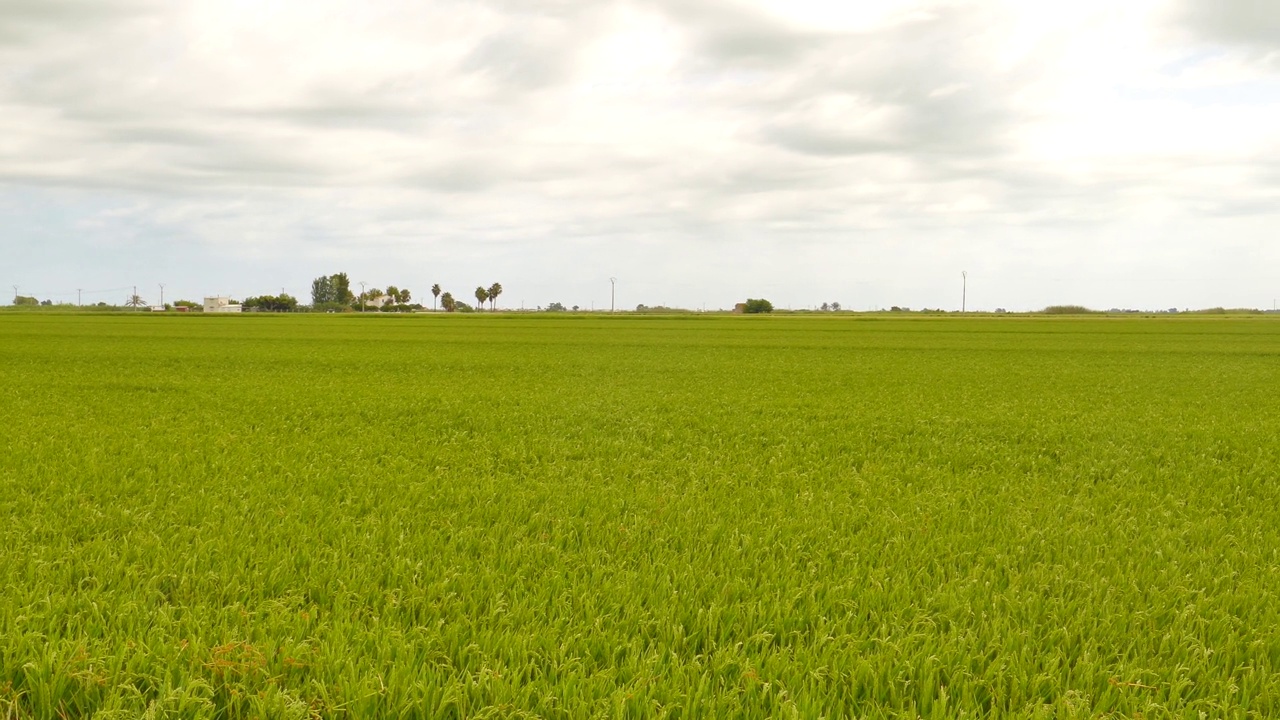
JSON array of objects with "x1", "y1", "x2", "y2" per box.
[{"x1": 0, "y1": 0, "x2": 1280, "y2": 310}]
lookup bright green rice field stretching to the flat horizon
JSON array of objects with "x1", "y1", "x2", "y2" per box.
[{"x1": 0, "y1": 314, "x2": 1280, "y2": 719}]
